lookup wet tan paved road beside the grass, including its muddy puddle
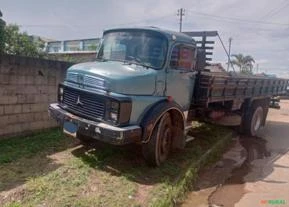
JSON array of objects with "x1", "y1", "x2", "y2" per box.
[{"x1": 182, "y1": 101, "x2": 289, "y2": 207}]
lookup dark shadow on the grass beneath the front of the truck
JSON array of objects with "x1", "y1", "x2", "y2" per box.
[{"x1": 72, "y1": 125, "x2": 230, "y2": 185}]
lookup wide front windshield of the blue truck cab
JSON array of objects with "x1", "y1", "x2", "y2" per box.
[{"x1": 98, "y1": 31, "x2": 167, "y2": 69}]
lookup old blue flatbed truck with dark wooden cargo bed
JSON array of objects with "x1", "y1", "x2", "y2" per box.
[{"x1": 48, "y1": 27, "x2": 288, "y2": 166}]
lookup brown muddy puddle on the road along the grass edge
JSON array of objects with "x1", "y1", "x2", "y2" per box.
[{"x1": 181, "y1": 137, "x2": 271, "y2": 207}]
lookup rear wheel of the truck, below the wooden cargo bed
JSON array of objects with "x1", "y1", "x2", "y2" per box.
[{"x1": 244, "y1": 104, "x2": 264, "y2": 136}]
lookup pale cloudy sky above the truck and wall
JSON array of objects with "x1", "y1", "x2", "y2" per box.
[{"x1": 0, "y1": 0, "x2": 289, "y2": 78}]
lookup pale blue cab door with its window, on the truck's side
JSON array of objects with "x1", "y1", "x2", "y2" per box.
[{"x1": 166, "y1": 44, "x2": 196, "y2": 111}]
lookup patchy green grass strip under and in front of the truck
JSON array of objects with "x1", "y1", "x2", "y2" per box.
[{"x1": 0, "y1": 124, "x2": 230, "y2": 207}]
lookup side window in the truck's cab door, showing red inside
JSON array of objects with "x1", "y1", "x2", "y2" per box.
[{"x1": 170, "y1": 45, "x2": 195, "y2": 71}]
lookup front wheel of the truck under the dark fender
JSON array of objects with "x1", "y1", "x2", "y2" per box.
[{"x1": 142, "y1": 113, "x2": 173, "y2": 167}]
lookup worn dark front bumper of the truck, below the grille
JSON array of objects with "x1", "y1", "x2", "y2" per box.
[{"x1": 48, "y1": 103, "x2": 142, "y2": 145}]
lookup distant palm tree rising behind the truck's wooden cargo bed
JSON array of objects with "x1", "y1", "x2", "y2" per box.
[{"x1": 231, "y1": 54, "x2": 255, "y2": 74}]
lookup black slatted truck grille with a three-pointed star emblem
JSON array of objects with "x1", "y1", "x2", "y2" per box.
[{"x1": 63, "y1": 87, "x2": 105, "y2": 119}]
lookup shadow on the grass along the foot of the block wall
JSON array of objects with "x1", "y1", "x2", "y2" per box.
[{"x1": 0, "y1": 129, "x2": 79, "y2": 192}]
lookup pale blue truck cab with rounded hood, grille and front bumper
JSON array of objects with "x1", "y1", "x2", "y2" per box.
[{"x1": 49, "y1": 27, "x2": 196, "y2": 165}]
